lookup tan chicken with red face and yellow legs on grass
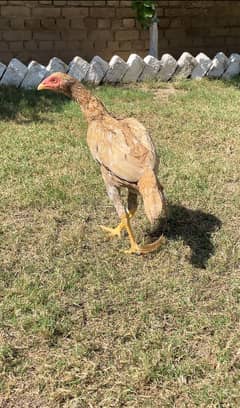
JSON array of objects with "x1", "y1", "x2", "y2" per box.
[{"x1": 38, "y1": 72, "x2": 166, "y2": 254}]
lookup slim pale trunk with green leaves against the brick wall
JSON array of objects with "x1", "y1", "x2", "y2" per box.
[{"x1": 132, "y1": 0, "x2": 158, "y2": 58}]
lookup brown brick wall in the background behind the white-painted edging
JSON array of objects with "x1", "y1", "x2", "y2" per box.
[{"x1": 0, "y1": 0, "x2": 240, "y2": 63}]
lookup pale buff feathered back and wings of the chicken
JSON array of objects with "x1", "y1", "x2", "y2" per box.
[{"x1": 87, "y1": 117, "x2": 156, "y2": 183}]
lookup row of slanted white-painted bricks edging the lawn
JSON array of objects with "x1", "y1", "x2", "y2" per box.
[{"x1": 0, "y1": 52, "x2": 240, "y2": 89}]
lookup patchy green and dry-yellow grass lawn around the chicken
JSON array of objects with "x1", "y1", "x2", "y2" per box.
[{"x1": 0, "y1": 80, "x2": 240, "y2": 408}]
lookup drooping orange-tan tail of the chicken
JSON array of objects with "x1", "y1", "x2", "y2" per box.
[{"x1": 138, "y1": 169, "x2": 167, "y2": 224}]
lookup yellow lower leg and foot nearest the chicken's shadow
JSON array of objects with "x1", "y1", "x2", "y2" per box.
[{"x1": 121, "y1": 214, "x2": 164, "y2": 254}]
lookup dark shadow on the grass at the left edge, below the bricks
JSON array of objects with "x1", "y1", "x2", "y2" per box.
[{"x1": 0, "y1": 87, "x2": 70, "y2": 124}]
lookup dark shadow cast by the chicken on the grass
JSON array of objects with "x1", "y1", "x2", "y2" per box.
[{"x1": 151, "y1": 204, "x2": 222, "y2": 269}]
